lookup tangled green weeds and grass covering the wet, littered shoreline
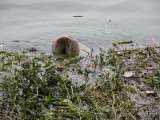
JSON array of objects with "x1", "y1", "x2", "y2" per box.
[{"x1": 0, "y1": 44, "x2": 160, "y2": 120}]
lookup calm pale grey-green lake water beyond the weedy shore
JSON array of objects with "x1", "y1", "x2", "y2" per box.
[{"x1": 0, "y1": 0, "x2": 160, "y2": 54}]
